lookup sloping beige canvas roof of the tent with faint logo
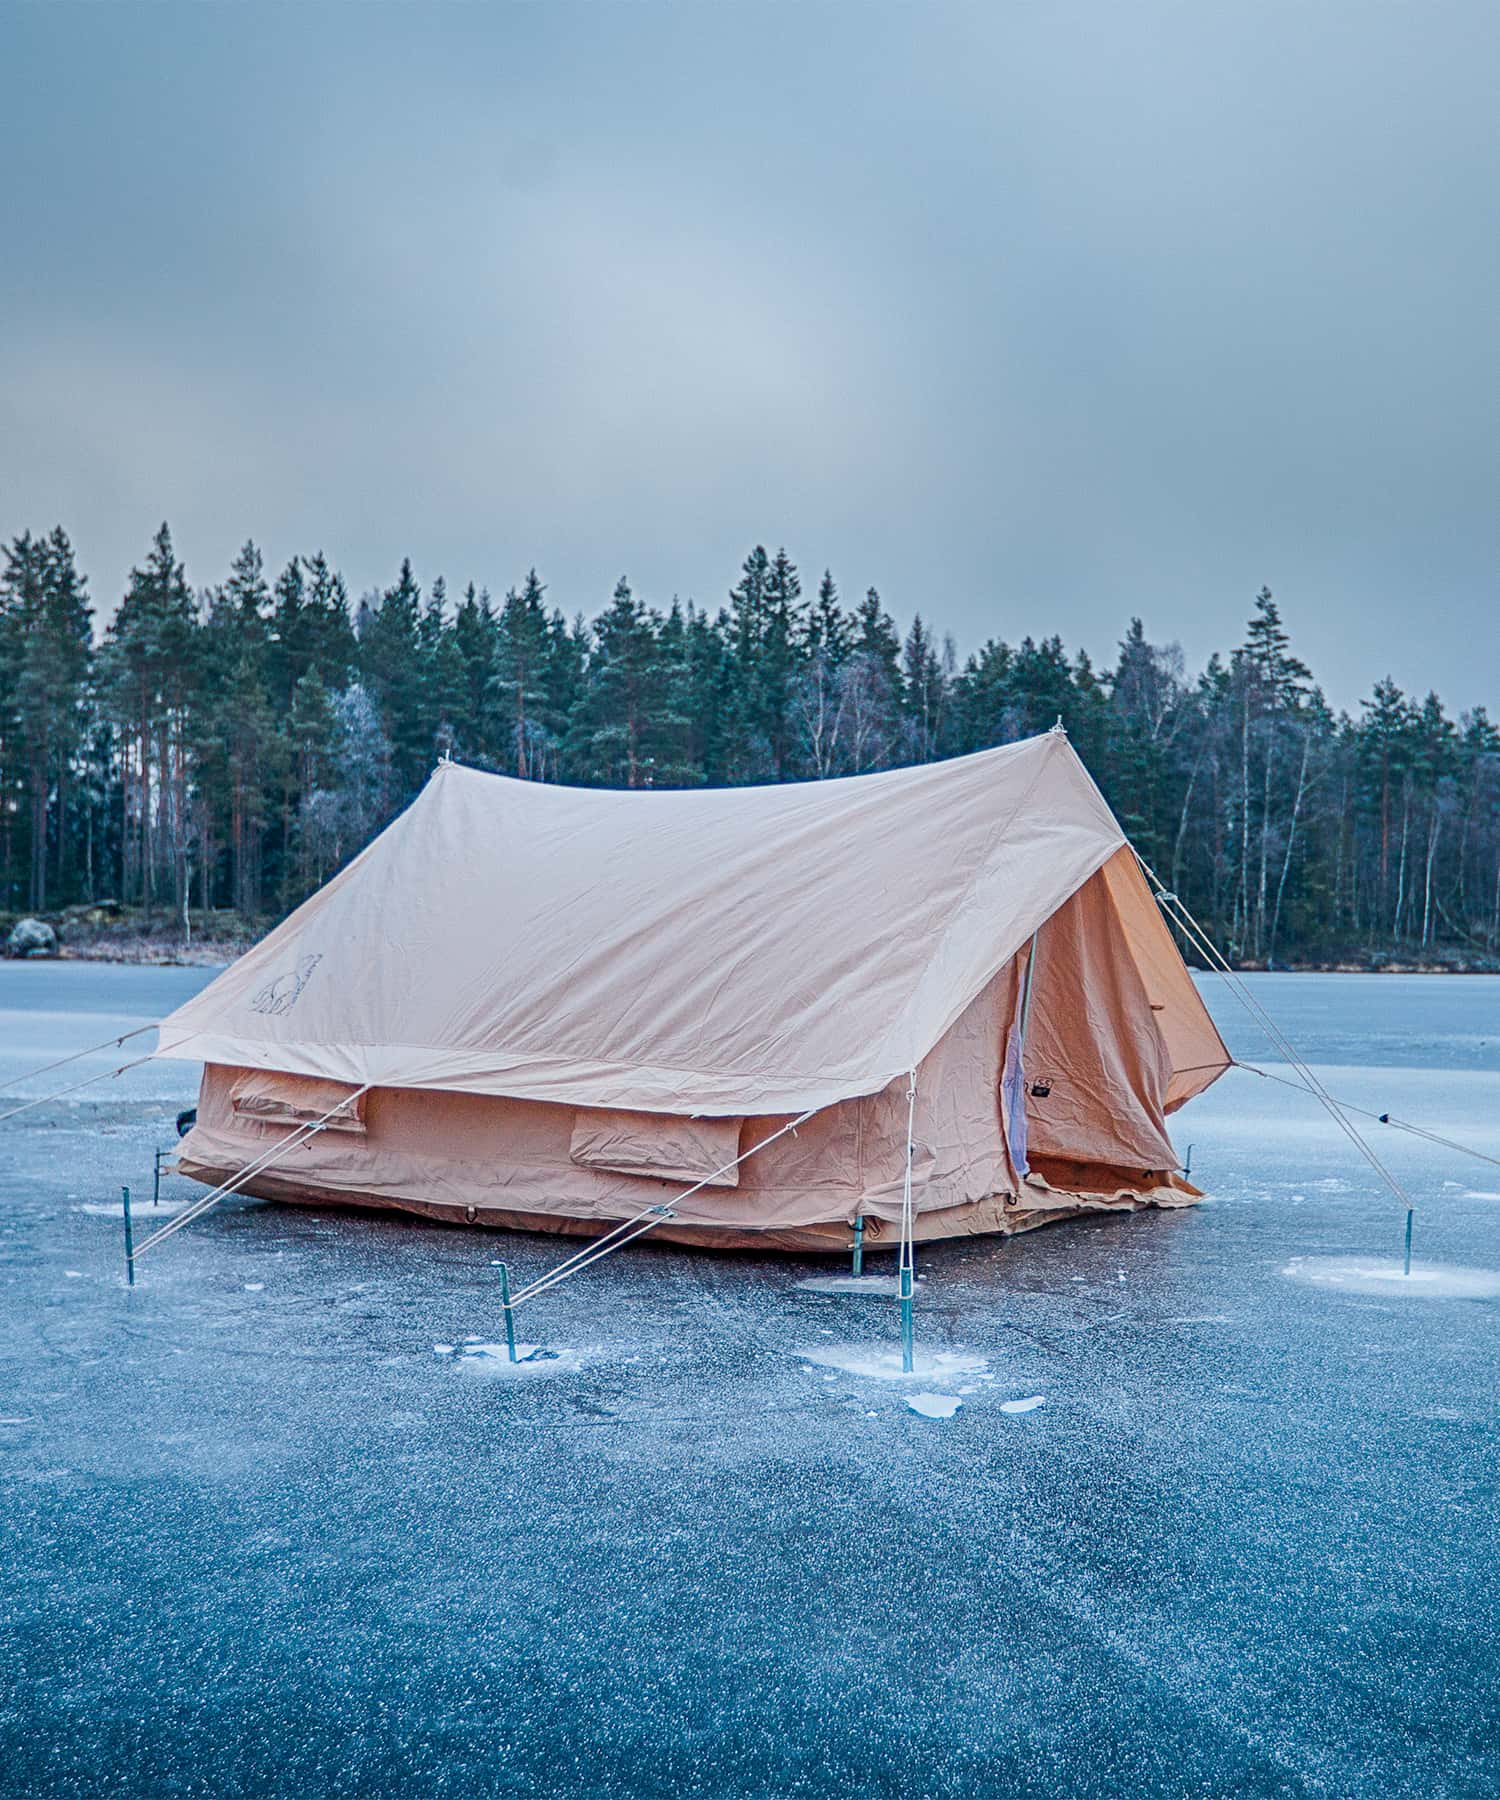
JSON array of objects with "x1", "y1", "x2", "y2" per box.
[{"x1": 158, "y1": 733, "x2": 1212, "y2": 1114}]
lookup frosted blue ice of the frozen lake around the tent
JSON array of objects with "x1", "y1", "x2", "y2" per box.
[{"x1": 0, "y1": 965, "x2": 1500, "y2": 1800}]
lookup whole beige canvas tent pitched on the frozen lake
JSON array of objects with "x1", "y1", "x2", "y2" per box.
[{"x1": 162, "y1": 731, "x2": 1230, "y2": 1249}]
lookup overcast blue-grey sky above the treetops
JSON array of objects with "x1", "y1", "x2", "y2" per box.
[{"x1": 0, "y1": 0, "x2": 1500, "y2": 709}]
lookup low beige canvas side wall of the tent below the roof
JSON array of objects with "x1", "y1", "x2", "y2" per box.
[{"x1": 178, "y1": 965, "x2": 1016, "y2": 1235}]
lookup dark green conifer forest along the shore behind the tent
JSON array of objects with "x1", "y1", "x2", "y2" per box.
[{"x1": 0, "y1": 526, "x2": 1500, "y2": 968}]
